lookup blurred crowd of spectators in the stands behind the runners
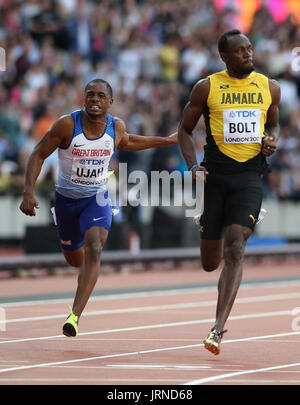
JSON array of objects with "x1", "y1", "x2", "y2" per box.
[{"x1": 0, "y1": 0, "x2": 300, "y2": 200}]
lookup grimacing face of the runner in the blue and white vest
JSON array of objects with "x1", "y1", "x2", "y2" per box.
[{"x1": 84, "y1": 82, "x2": 113, "y2": 117}]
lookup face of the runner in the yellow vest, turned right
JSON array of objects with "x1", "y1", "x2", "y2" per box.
[{"x1": 221, "y1": 34, "x2": 254, "y2": 75}]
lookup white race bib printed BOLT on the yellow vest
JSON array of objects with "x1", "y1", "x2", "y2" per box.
[{"x1": 223, "y1": 108, "x2": 261, "y2": 144}]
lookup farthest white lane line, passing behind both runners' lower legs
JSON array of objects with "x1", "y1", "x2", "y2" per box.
[{"x1": 0, "y1": 280, "x2": 300, "y2": 308}]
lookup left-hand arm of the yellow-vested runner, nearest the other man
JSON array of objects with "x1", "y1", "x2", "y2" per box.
[{"x1": 178, "y1": 79, "x2": 210, "y2": 177}]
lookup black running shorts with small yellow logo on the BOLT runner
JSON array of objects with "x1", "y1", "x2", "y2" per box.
[{"x1": 200, "y1": 171, "x2": 262, "y2": 240}]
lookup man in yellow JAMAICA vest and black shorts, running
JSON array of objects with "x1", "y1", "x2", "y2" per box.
[{"x1": 178, "y1": 30, "x2": 280, "y2": 354}]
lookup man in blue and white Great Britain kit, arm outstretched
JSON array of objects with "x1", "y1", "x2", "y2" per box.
[{"x1": 20, "y1": 79, "x2": 177, "y2": 336}]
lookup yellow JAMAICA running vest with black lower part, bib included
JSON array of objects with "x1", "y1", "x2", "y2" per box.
[{"x1": 202, "y1": 70, "x2": 272, "y2": 173}]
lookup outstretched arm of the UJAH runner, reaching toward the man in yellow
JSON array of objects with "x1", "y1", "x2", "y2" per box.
[{"x1": 116, "y1": 118, "x2": 178, "y2": 151}]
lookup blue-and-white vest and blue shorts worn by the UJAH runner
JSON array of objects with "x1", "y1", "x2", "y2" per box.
[{"x1": 52, "y1": 110, "x2": 115, "y2": 251}]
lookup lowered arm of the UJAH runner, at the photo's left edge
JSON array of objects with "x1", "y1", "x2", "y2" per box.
[{"x1": 20, "y1": 116, "x2": 74, "y2": 216}]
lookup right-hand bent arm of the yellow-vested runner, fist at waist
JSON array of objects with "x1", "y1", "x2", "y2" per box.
[{"x1": 262, "y1": 79, "x2": 280, "y2": 156}]
